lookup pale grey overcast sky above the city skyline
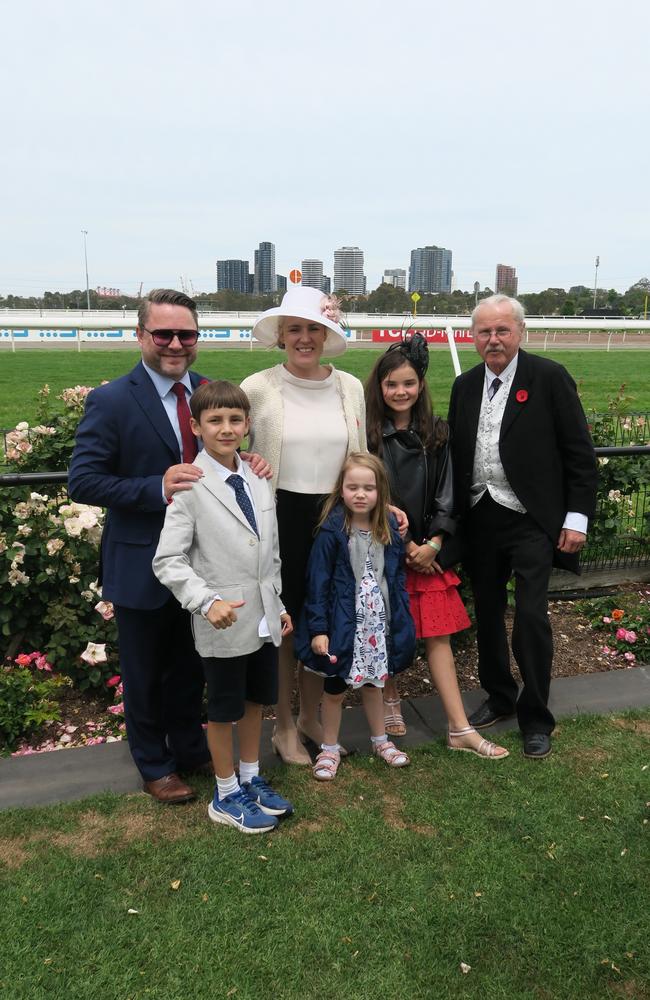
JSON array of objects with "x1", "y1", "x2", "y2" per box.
[{"x1": 0, "y1": 0, "x2": 650, "y2": 295}]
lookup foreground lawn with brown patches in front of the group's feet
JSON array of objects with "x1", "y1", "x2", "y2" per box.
[{"x1": 0, "y1": 711, "x2": 650, "y2": 1000}]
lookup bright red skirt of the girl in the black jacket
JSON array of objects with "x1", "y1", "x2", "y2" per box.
[{"x1": 406, "y1": 567, "x2": 472, "y2": 639}]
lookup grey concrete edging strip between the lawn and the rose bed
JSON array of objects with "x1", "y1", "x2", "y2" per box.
[{"x1": 0, "y1": 667, "x2": 650, "y2": 810}]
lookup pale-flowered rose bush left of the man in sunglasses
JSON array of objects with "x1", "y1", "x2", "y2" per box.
[{"x1": 0, "y1": 385, "x2": 117, "y2": 689}]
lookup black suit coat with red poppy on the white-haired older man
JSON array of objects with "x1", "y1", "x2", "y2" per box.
[{"x1": 449, "y1": 350, "x2": 598, "y2": 572}]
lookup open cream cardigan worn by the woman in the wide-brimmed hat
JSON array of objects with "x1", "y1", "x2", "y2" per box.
[{"x1": 241, "y1": 365, "x2": 368, "y2": 491}]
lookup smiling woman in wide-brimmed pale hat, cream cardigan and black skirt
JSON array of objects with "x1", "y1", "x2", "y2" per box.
[{"x1": 242, "y1": 287, "x2": 367, "y2": 764}]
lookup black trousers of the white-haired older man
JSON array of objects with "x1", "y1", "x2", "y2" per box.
[{"x1": 468, "y1": 493, "x2": 555, "y2": 733}]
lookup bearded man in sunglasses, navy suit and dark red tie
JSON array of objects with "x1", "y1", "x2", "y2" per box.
[{"x1": 68, "y1": 289, "x2": 256, "y2": 803}]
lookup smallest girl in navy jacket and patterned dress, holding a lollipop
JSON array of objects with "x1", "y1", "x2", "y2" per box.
[{"x1": 295, "y1": 452, "x2": 415, "y2": 781}]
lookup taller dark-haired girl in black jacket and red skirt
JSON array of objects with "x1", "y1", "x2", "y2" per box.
[{"x1": 366, "y1": 333, "x2": 508, "y2": 759}]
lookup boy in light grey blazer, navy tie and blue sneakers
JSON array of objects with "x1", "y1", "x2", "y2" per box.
[{"x1": 153, "y1": 381, "x2": 293, "y2": 833}]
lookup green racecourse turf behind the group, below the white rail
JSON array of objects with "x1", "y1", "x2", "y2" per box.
[{"x1": 0, "y1": 348, "x2": 650, "y2": 428}]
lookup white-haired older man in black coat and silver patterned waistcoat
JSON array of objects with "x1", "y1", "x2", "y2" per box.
[{"x1": 449, "y1": 295, "x2": 597, "y2": 758}]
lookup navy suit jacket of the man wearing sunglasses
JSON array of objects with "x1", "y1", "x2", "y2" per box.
[{"x1": 68, "y1": 363, "x2": 202, "y2": 610}]
